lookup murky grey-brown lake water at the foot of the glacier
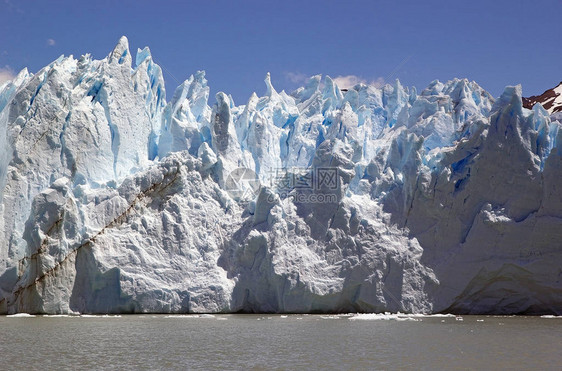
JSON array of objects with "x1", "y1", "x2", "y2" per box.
[{"x1": 0, "y1": 314, "x2": 562, "y2": 370}]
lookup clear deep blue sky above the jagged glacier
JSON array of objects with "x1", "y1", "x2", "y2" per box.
[{"x1": 0, "y1": 0, "x2": 562, "y2": 104}]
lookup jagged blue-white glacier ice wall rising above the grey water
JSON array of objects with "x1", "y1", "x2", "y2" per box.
[{"x1": 0, "y1": 38, "x2": 562, "y2": 314}]
